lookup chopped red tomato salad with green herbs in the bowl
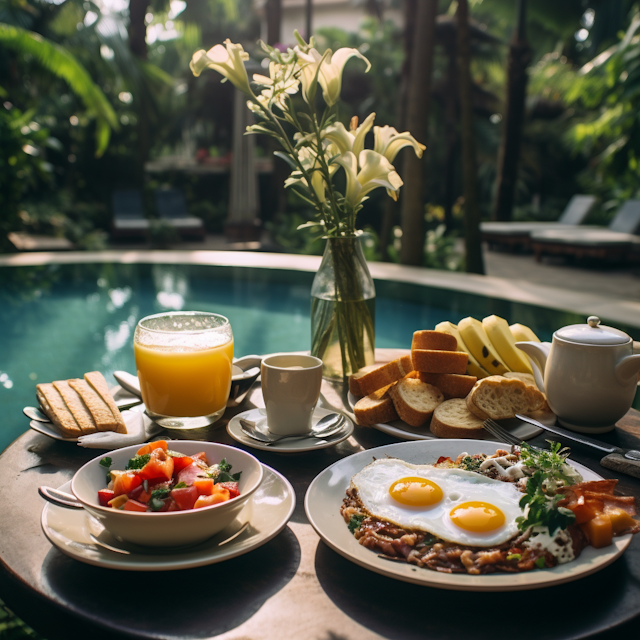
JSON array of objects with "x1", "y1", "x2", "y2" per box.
[{"x1": 98, "y1": 440, "x2": 242, "y2": 512}]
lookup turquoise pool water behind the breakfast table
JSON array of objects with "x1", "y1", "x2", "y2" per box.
[{"x1": 0, "y1": 264, "x2": 640, "y2": 450}]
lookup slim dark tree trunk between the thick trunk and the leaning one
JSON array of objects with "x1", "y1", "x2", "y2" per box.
[{"x1": 456, "y1": 0, "x2": 484, "y2": 274}]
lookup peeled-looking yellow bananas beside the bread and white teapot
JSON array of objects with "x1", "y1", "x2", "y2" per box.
[{"x1": 442, "y1": 315, "x2": 540, "y2": 378}]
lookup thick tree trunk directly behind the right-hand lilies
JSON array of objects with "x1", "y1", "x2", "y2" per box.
[{"x1": 400, "y1": 0, "x2": 438, "y2": 265}]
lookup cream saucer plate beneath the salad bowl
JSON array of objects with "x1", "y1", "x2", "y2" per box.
[{"x1": 40, "y1": 465, "x2": 296, "y2": 571}]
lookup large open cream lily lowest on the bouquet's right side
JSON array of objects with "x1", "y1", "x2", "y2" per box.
[{"x1": 336, "y1": 149, "x2": 403, "y2": 207}]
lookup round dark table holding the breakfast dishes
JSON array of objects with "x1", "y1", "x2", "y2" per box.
[{"x1": 0, "y1": 350, "x2": 640, "y2": 640}]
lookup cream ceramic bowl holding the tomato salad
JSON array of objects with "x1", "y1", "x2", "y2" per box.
[{"x1": 71, "y1": 440, "x2": 263, "y2": 547}]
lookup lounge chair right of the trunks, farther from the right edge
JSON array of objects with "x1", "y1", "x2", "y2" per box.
[{"x1": 480, "y1": 195, "x2": 596, "y2": 249}]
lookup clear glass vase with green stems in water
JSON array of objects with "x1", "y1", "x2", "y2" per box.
[{"x1": 311, "y1": 236, "x2": 376, "y2": 379}]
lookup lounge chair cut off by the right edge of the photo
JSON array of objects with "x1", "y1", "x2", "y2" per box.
[{"x1": 531, "y1": 200, "x2": 640, "y2": 262}]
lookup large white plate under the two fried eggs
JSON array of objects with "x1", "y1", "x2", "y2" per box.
[{"x1": 304, "y1": 439, "x2": 632, "y2": 591}]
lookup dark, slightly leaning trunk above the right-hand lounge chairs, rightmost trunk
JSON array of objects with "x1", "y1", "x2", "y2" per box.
[{"x1": 493, "y1": 0, "x2": 531, "y2": 220}]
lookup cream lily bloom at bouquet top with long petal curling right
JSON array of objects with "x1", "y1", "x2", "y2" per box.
[{"x1": 295, "y1": 47, "x2": 371, "y2": 106}]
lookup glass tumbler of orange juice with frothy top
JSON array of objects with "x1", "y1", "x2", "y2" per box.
[{"x1": 133, "y1": 311, "x2": 233, "y2": 429}]
